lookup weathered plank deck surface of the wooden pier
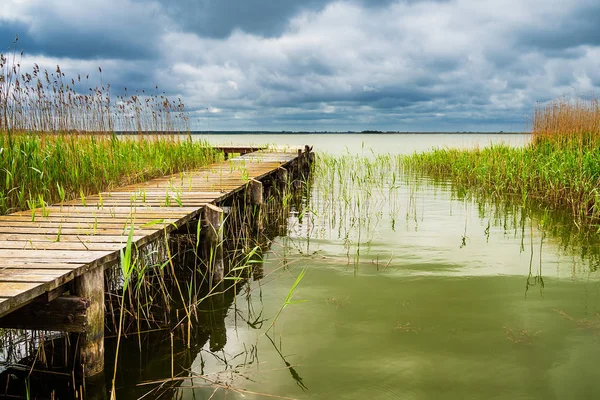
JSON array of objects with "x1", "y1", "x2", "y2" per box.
[{"x1": 0, "y1": 148, "x2": 310, "y2": 376}]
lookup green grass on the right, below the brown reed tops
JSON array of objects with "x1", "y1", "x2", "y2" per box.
[{"x1": 404, "y1": 140, "x2": 600, "y2": 223}]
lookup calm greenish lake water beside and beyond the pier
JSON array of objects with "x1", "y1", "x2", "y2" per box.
[{"x1": 122, "y1": 134, "x2": 600, "y2": 399}]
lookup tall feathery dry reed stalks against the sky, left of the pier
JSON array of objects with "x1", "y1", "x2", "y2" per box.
[{"x1": 0, "y1": 41, "x2": 190, "y2": 134}]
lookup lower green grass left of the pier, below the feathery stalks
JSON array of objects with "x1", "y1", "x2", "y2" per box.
[{"x1": 0, "y1": 134, "x2": 222, "y2": 214}]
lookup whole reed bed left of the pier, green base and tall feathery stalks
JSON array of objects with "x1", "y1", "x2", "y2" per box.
[{"x1": 0, "y1": 41, "x2": 221, "y2": 214}]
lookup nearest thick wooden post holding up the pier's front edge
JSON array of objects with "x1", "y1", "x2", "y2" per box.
[{"x1": 73, "y1": 266, "x2": 104, "y2": 377}]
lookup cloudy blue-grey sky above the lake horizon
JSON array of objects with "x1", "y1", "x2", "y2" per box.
[{"x1": 0, "y1": 0, "x2": 600, "y2": 131}]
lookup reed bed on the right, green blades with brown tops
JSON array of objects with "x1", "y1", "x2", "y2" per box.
[{"x1": 404, "y1": 94, "x2": 600, "y2": 225}]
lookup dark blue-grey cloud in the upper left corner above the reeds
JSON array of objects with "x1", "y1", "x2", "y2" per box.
[{"x1": 0, "y1": 0, "x2": 169, "y2": 60}]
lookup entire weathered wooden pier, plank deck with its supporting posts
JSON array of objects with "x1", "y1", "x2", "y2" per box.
[{"x1": 0, "y1": 146, "x2": 311, "y2": 376}]
